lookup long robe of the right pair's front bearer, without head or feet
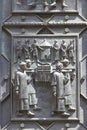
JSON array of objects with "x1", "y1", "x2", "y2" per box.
[{"x1": 51, "y1": 71, "x2": 65, "y2": 112}]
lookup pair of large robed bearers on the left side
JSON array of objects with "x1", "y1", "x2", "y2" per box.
[{"x1": 15, "y1": 60, "x2": 40, "y2": 116}]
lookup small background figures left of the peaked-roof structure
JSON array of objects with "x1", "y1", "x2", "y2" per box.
[{"x1": 15, "y1": 39, "x2": 42, "y2": 62}]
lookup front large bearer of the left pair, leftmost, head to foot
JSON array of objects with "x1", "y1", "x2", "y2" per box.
[{"x1": 15, "y1": 62, "x2": 34, "y2": 116}]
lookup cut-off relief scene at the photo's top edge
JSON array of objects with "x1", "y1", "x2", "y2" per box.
[{"x1": 12, "y1": 0, "x2": 77, "y2": 12}]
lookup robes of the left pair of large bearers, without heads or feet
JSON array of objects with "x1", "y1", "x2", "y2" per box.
[{"x1": 15, "y1": 71, "x2": 37, "y2": 111}]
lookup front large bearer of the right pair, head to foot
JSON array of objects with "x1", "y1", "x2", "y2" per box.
[{"x1": 51, "y1": 62, "x2": 70, "y2": 116}]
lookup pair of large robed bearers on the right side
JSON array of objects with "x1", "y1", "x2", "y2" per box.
[{"x1": 51, "y1": 60, "x2": 75, "y2": 116}]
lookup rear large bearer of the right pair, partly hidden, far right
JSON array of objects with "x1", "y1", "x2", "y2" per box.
[{"x1": 63, "y1": 59, "x2": 76, "y2": 111}]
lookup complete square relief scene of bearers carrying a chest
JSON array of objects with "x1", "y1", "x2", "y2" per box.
[{"x1": 11, "y1": 37, "x2": 78, "y2": 119}]
